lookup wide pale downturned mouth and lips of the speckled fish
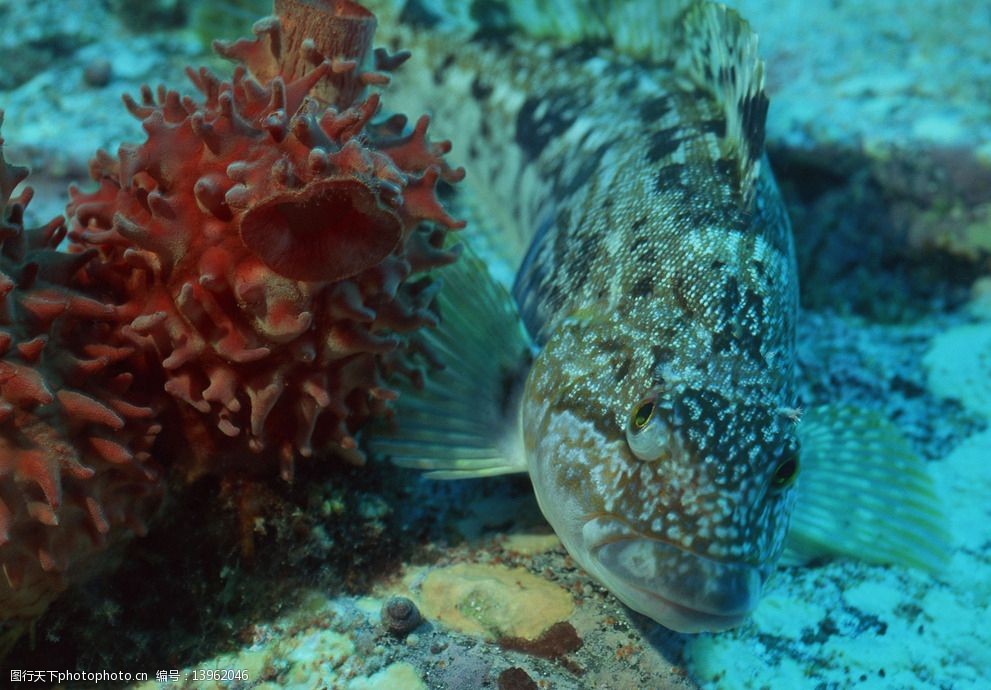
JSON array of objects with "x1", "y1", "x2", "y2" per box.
[{"x1": 582, "y1": 518, "x2": 763, "y2": 633}]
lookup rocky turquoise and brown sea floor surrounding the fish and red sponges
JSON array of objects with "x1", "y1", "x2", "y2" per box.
[{"x1": 0, "y1": 0, "x2": 991, "y2": 690}]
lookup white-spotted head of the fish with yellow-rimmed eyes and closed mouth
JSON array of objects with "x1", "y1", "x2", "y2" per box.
[{"x1": 521, "y1": 307, "x2": 798, "y2": 632}]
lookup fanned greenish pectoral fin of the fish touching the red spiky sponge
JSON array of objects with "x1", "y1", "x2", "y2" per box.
[{"x1": 366, "y1": 242, "x2": 533, "y2": 479}]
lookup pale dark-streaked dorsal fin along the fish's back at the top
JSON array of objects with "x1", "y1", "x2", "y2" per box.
[{"x1": 505, "y1": 0, "x2": 768, "y2": 206}]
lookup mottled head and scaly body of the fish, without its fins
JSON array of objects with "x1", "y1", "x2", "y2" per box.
[{"x1": 372, "y1": 1, "x2": 798, "y2": 631}]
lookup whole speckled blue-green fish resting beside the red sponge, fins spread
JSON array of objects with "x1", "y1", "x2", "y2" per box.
[{"x1": 365, "y1": 0, "x2": 947, "y2": 633}]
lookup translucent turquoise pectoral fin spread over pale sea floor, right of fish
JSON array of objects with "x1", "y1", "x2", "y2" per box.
[{"x1": 782, "y1": 406, "x2": 950, "y2": 571}]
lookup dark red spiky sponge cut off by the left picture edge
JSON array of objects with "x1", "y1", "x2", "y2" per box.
[{"x1": 0, "y1": 111, "x2": 161, "y2": 620}]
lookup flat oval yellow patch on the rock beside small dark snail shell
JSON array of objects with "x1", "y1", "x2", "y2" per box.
[{"x1": 419, "y1": 563, "x2": 574, "y2": 640}]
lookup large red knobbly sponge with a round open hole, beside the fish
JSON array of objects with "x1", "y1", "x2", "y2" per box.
[{"x1": 68, "y1": 0, "x2": 463, "y2": 478}]
